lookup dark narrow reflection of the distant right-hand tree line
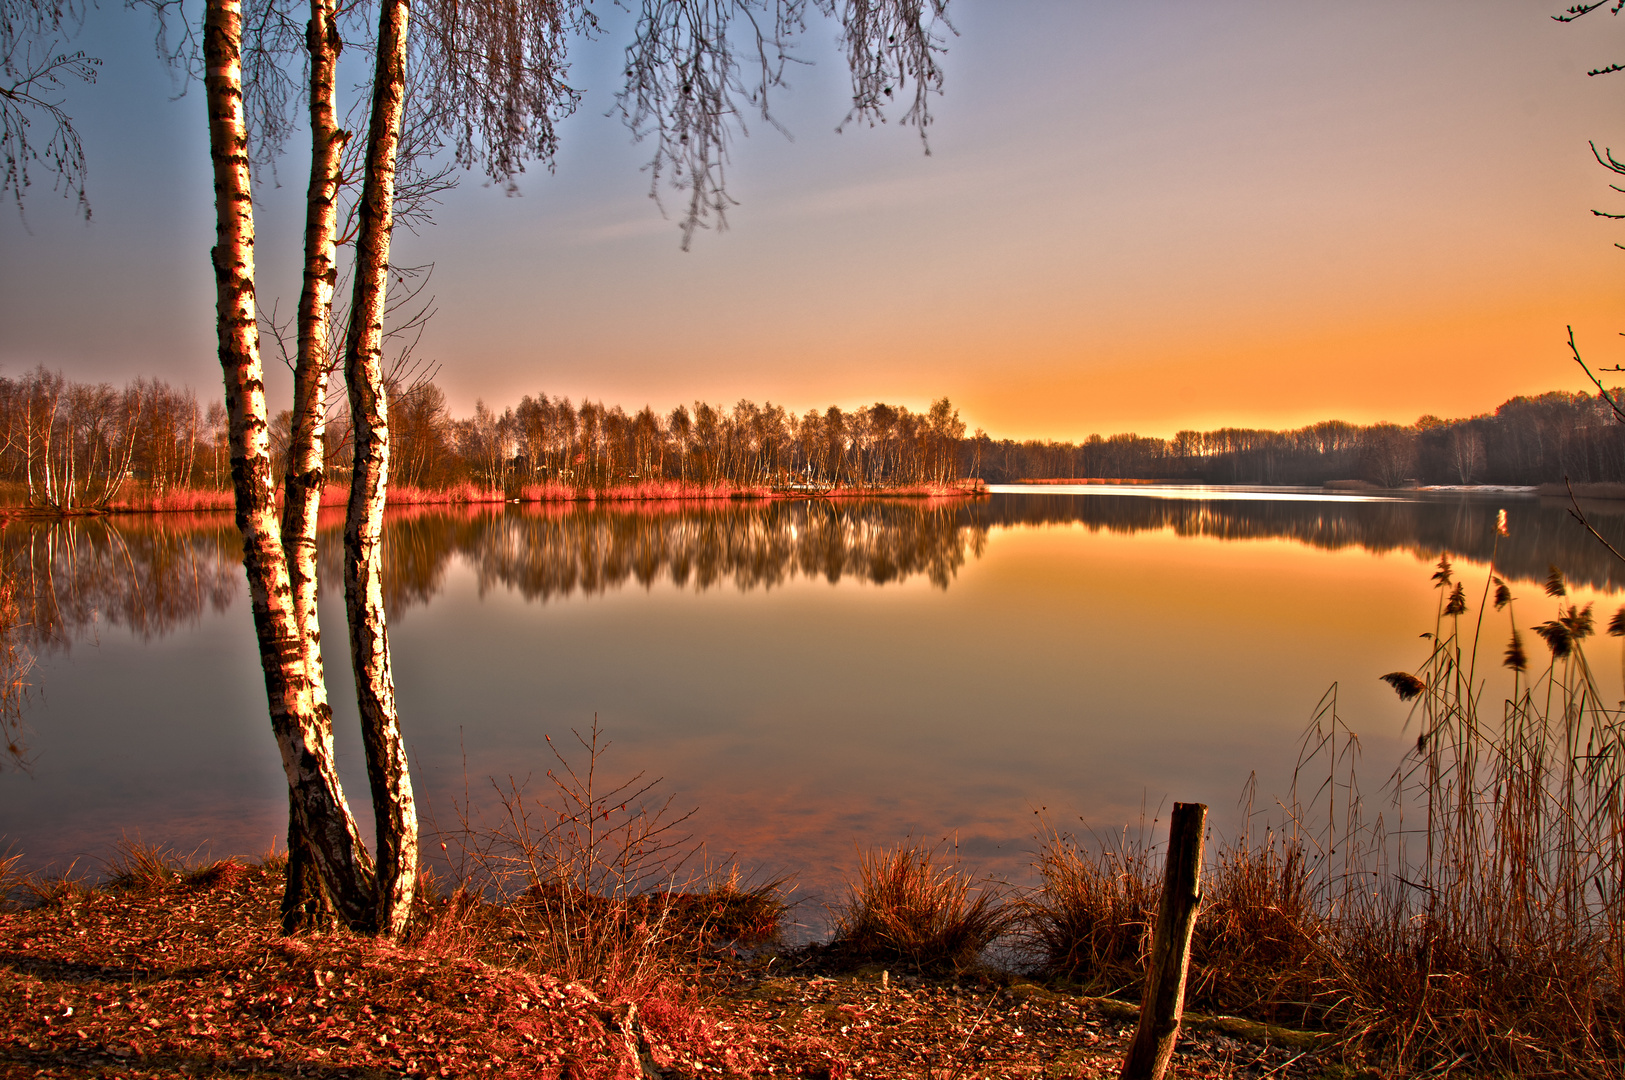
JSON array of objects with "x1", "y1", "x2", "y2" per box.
[{"x1": 972, "y1": 494, "x2": 1625, "y2": 590}]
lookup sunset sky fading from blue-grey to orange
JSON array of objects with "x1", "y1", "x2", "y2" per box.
[{"x1": 0, "y1": 0, "x2": 1625, "y2": 438}]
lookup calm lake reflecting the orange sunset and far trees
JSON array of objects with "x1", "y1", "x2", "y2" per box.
[{"x1": 0, "y1": 486, "x2": 1625, "y2": 898}]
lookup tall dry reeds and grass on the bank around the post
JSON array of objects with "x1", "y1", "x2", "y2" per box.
[{"x1": 1022, "y1": 542, "x2": 1625, "y2": 1077}]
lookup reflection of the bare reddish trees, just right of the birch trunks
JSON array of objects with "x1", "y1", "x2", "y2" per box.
[{"x1": 360, "y1": 500, "x2": 986, "y2": 611}]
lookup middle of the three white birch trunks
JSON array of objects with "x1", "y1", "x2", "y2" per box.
[{"x1": 283, "y1": 0, "x2": 349, "y2": 934}]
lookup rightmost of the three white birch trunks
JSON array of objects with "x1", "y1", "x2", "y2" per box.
[{"x1": 345, "y1": 0, "x2": 418, "y2": 935}]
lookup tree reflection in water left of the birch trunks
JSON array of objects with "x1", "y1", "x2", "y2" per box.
[{"x1": 0, "y1": 515, "x2": 242, "y2": 648}]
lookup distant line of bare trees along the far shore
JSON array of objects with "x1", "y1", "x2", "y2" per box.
[{"x1": 0, "y1": 367, "x2": 1625, "y2": 510}]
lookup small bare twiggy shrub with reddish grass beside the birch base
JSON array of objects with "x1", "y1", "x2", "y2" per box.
[{"x1": 432, "y1": 721, "x2": 787, "y2": 1000}]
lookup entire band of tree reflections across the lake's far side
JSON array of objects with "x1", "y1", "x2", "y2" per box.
[{"x1": 9, "y1": 492, "x2": 1625, "y2": 648}]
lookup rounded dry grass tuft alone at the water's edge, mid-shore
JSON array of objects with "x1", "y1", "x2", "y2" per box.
[{"x1": 832, "y1": 841, "x2": 1016, "y2": 971}]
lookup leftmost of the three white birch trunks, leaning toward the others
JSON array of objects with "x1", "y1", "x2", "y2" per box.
[{"x1": 203, "y1": 0, "x2": 372, "y2": 927}]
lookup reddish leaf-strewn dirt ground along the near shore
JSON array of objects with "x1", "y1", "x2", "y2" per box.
[{"x1": 0, "y1": 862, "x2": 1342, "y2": 1080}]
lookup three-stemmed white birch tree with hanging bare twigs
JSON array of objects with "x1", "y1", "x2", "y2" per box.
[{"x1": 188, "y1": 0, "x2": 946, "y2": 934}]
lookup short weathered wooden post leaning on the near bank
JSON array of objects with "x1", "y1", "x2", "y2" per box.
[{"x1": 1121, "y1": 802, "x2": 1207, "y2": 1080}]
